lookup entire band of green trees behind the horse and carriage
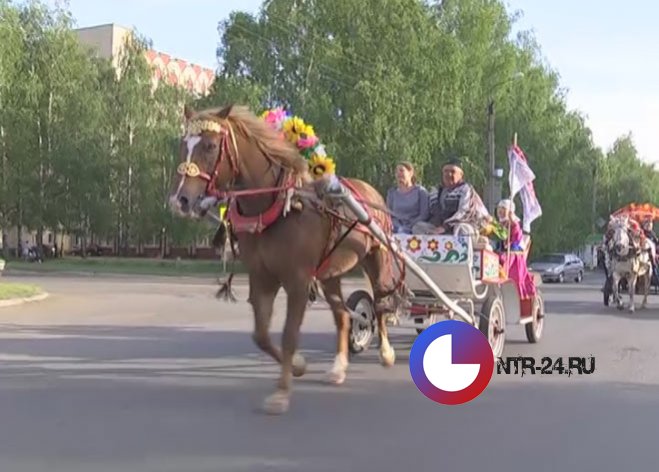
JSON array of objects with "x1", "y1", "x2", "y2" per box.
[{"x1": 0, "y1": 0, "x2": 659, "y2": 258}]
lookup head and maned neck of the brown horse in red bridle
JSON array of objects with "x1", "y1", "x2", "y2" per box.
[{"x1": 169, "y1": 105, "x2": 308, "y2": 218}]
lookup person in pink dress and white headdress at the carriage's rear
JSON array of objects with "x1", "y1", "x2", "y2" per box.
[{"x1": 497, "y1": 199, "x2": 536, "y2": 300}]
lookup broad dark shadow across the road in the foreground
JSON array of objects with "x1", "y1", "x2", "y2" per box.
[{"x1": 0, "y1": 368, "x2": 659, "y2": 472}]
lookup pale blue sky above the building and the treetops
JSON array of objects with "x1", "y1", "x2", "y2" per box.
[{"x1": 50, "y1": 0, "x2": 659, "y2": 162}]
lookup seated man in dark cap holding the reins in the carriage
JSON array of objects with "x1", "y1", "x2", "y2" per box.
[{"x1": 412, "y1": 158, "x2": 492, "y2": 234}]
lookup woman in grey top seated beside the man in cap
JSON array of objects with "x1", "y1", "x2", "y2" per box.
[{"x1": 387, "y1": 162, "x2": 429, "y2": 234}]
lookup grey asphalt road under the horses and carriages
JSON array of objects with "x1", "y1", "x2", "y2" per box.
[{"x1": 0, "y1": 277, "x2": 659, "y2": 472}]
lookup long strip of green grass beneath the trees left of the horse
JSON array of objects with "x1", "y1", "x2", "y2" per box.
[{"x1": 5, "y1": 257, "x2": 243, "y2": 276}]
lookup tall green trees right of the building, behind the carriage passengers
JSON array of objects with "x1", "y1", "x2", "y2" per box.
[{"x1": 211, "y1": 0, "x2": 657, "y2": 252}]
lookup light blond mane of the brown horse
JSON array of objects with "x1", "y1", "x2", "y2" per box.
[{"x1": 195, "y1": 105, "x2": 309, "y2": 180}]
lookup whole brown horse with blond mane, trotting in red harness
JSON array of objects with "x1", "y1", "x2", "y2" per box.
[{"x1": 170, "y1": 106, "x2": 401, "y2": 414}]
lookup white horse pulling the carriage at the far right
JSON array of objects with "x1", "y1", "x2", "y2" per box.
[{"x1": 607, "y1": 217, "x2": 652, "y2": 313}]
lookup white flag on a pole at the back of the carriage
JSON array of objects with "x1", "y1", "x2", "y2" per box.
[{"x1": 508, "y1": 146, "x2": 542, "y2": 233}]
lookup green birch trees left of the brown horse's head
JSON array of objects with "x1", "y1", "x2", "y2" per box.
[{"x1": 0, "y1": 1, "x2": 196, "y2": 254}]
